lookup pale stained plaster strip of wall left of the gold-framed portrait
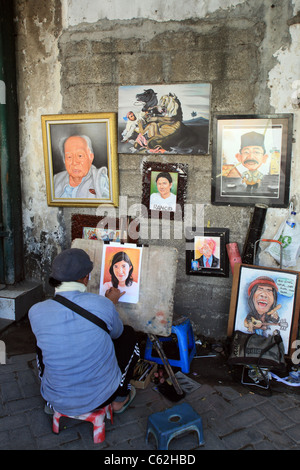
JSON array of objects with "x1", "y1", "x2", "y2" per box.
[{"x1": 16, "y1": 1, "x2": 64, "y2": 286}]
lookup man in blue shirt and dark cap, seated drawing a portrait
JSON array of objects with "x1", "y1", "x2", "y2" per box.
[{"x1": 29, "y1": 248, "x2": 139, "y2": 416}]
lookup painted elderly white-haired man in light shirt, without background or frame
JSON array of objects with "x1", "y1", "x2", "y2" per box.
[{"x1": 54, "y1": 135, "x2": 109, "y2": 199}]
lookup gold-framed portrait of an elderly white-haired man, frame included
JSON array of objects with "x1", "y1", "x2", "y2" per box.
[{"x1": 41, "y1": 113, "x2": 119, "y2": 207}]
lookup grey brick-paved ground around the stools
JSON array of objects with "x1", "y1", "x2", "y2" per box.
[{"x1": 0, "y1": 354, "x2": 300, "y2": 452}]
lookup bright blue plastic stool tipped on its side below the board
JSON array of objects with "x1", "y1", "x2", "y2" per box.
[{"x1": 144, "y1": 319, "x2": 196, "y2": 374}]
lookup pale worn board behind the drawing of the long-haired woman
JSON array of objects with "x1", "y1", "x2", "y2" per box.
[{"x1": 72, "y1": 238, "x2": 178, "y2": 336}]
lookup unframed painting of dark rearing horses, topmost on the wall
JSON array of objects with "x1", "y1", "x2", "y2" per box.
[{"x1": 118, "y1": 83, "x2": 211, "y2": 155}]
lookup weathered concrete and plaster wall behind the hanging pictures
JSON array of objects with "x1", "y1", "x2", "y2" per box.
[{"x1": 15, "y1": 0, "x2": 300, "y2": 338}]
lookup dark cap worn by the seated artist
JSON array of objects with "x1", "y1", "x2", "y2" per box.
[{"x1": 50, "y1": 248, "x2": 93, "y2": 281}]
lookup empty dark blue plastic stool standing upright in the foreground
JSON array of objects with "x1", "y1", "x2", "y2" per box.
[{"x1": 146, "y1": 403, "x2": 204, "y2": 450}]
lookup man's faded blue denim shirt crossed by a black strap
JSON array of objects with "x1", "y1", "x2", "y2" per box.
[{"x1": 29, "y1": 291, "x2": 123, "y2": 416}]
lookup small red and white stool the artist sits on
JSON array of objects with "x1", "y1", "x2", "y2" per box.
[{"x1": 52, "y1": 405, "x2": 113, "y2": 444}]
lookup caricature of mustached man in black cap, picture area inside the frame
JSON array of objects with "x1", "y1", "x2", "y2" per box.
[{"x1": 220, "y1": 120, "x2": 282, "y2": 198}]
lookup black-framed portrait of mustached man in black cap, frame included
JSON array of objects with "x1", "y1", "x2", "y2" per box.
[{"x1": 212, "y1": 114, "x2": 293, "y2": 207}]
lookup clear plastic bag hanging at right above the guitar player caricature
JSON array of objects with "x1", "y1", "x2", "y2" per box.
[{"x1": 265, "y1": 204, "x2": 300, "y2": 267}]
